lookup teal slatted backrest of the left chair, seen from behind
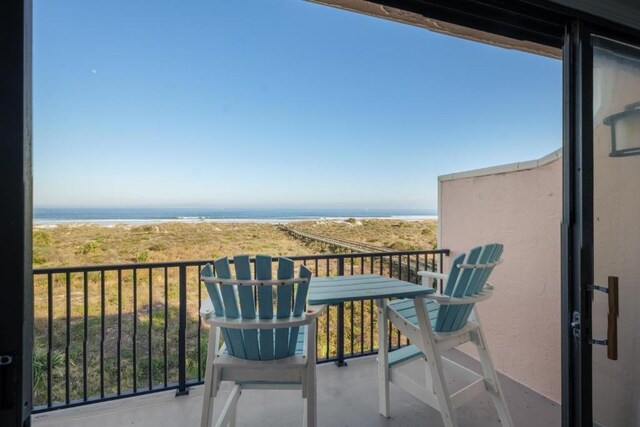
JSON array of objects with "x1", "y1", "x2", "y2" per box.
[{"x1": 201, "y1": 255, "x2": 311, "y2": 360}]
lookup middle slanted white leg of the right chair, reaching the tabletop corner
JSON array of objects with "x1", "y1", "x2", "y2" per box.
[{"x1": 413, "y1": 297, "x2": 458, "y2": 427}]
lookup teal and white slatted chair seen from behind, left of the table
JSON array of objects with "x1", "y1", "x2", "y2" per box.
[{"x1": 200, "y1": 255, "x2": 324, "y2": 427}]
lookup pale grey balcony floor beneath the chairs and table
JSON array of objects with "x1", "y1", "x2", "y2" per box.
[{"x1": 32, "y1": 350, "x2": 561, "y2": 427}]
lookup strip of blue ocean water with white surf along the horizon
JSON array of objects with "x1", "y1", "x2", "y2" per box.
[{"x1": 33, "y1": 207, "x2": 437, "y2": 225}]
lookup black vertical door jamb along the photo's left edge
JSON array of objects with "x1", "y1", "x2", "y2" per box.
[{"x1": 0, "y1": 0, "x2": 33, "y2": 426}]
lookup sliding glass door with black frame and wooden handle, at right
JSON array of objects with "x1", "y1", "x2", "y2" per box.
[{"x1": 563, "y1": 22, "x2": 640, "y2": 426}]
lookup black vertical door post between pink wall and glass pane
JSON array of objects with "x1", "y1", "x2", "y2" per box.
[{"x1": 561, "y1": 20, "x2": 593, "y2": 426}]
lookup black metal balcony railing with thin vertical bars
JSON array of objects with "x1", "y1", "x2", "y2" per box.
[{"x1": 33, "y1": 249, "x2": 449, "y2": 412}]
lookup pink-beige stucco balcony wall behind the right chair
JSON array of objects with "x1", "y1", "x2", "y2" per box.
[{"x1": 438, "y1": 152, "x2": 562, "y2": 402}]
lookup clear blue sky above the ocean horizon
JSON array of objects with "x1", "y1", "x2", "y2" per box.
[{"x1": 33, "y1": 0, "x2": 562, "y2": 209}]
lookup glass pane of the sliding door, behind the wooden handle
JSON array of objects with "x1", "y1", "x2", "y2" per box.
[{"x1": 592, "y1": 38, "x2": 640, "y2": 426}]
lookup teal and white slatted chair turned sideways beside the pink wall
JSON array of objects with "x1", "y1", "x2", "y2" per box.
[{"x1": 378, "y1": 243, "x2": 513, "y2": 426}]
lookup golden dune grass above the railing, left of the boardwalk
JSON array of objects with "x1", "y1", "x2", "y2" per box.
[{"x1": 33, "y1": 222, "x2": 318, "y2": 268}]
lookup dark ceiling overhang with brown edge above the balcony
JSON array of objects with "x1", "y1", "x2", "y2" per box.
[{"x1": 310, "y1": 0, "x2": 640, "y2": 58}]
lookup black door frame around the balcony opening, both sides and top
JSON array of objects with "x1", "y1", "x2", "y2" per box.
[{"x1": 7, "y1": 0, "x2": 640, "y2": 427}]
